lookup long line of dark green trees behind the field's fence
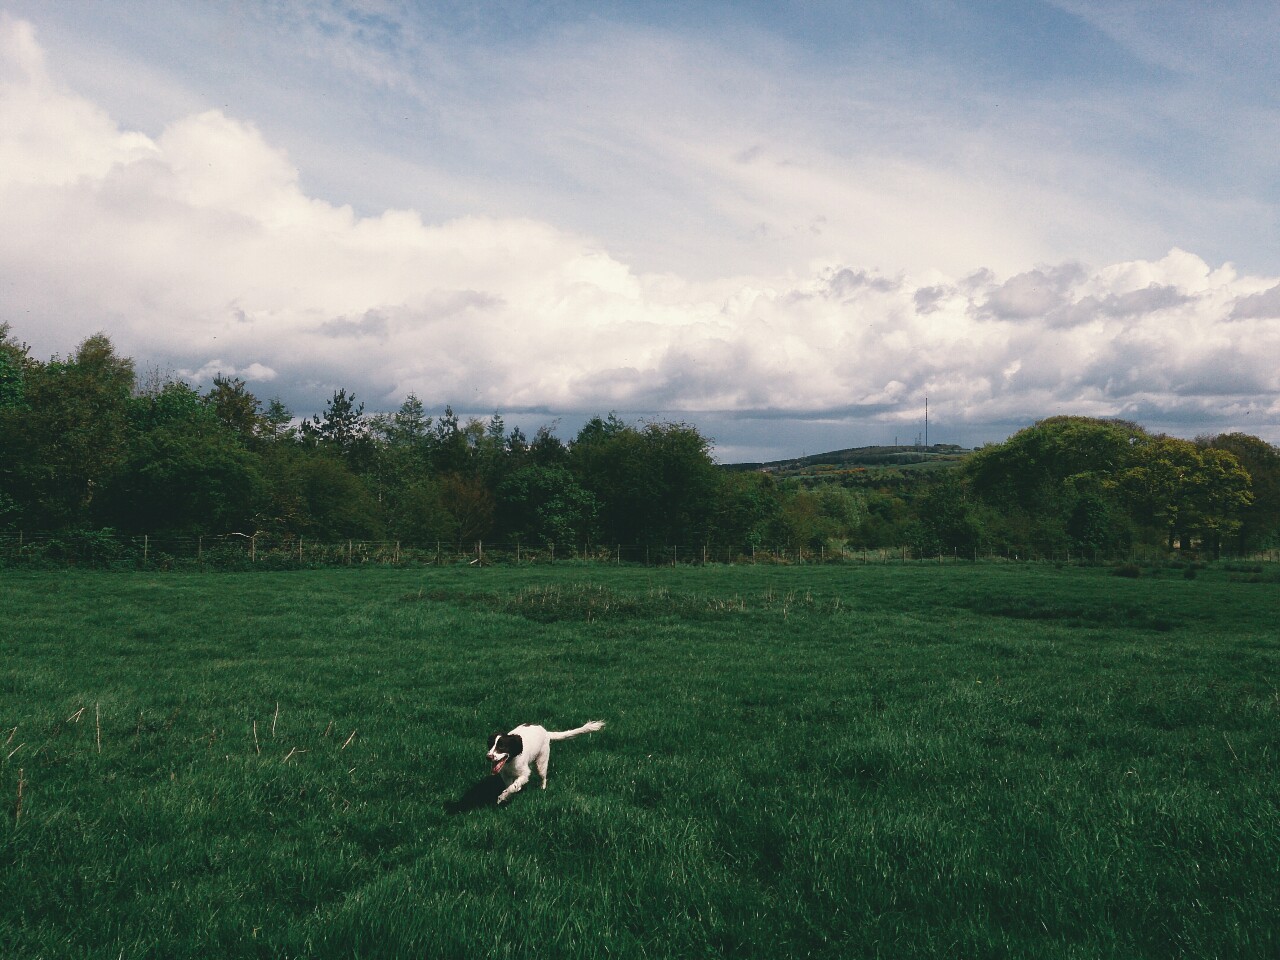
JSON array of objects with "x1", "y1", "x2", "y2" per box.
[{"x1": 0, "y1": 324, "x2": 1280, "y2": 558}]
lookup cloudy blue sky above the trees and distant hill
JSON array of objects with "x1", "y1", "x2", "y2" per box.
[{"x1": 0, "y1": 0, "x2": 1280, "y2": 462}]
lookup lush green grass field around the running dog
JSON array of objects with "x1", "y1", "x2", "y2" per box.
[{"x1": 0, "y1": 564, "x2": 1280, "y2": 960}]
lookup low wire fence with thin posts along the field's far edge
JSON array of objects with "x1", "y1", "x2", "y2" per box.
[{"x1": 0, "y1": 530, "x2": 1280, "y2": 570}]
